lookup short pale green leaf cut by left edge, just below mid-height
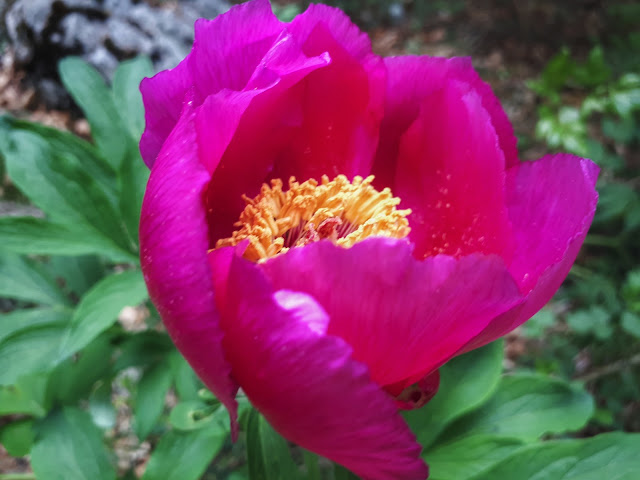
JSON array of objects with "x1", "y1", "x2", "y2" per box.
[{"x1": 0, "y1": 252, "x2": 71, "y2": 306}]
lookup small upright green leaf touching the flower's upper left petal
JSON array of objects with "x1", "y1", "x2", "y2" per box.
[{"x1": 113, "y1": 57, "x2": 154, "y2": 141}]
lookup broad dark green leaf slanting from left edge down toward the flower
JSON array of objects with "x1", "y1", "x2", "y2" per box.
[{"x1": 3, "y1": 130, "x2": 131, "y2": 251}]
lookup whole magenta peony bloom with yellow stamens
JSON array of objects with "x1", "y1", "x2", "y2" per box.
[{"x1": 140, "y1": 0, "x2": 598, "y2": 480}]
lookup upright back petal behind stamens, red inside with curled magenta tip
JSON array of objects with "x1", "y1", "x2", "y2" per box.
[{"x1": 262, "y1": 1, "x2": 386, "y2": 180}]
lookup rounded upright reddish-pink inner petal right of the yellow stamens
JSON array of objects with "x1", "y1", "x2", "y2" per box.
[{"x1": 393, "y1": 81, "x2": 513, "y2": 262}]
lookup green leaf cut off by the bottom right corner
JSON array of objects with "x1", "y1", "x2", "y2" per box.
[{"x1": 473, "y1": 433, "x2": 640, "y2": 480}]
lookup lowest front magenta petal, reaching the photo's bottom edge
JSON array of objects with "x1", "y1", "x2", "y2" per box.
[{"x1": 209, "y1": 248, "x2": 427, "y2": 480}]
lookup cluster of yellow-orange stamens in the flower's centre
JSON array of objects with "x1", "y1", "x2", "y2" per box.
[{"x1": 216, "y1": 175, "x2": 411, "y2": 262}]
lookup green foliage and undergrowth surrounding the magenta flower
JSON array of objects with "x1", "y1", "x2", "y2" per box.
[{"x1": 0, "y1": 0, "x2": 640, "y2": 480}]
